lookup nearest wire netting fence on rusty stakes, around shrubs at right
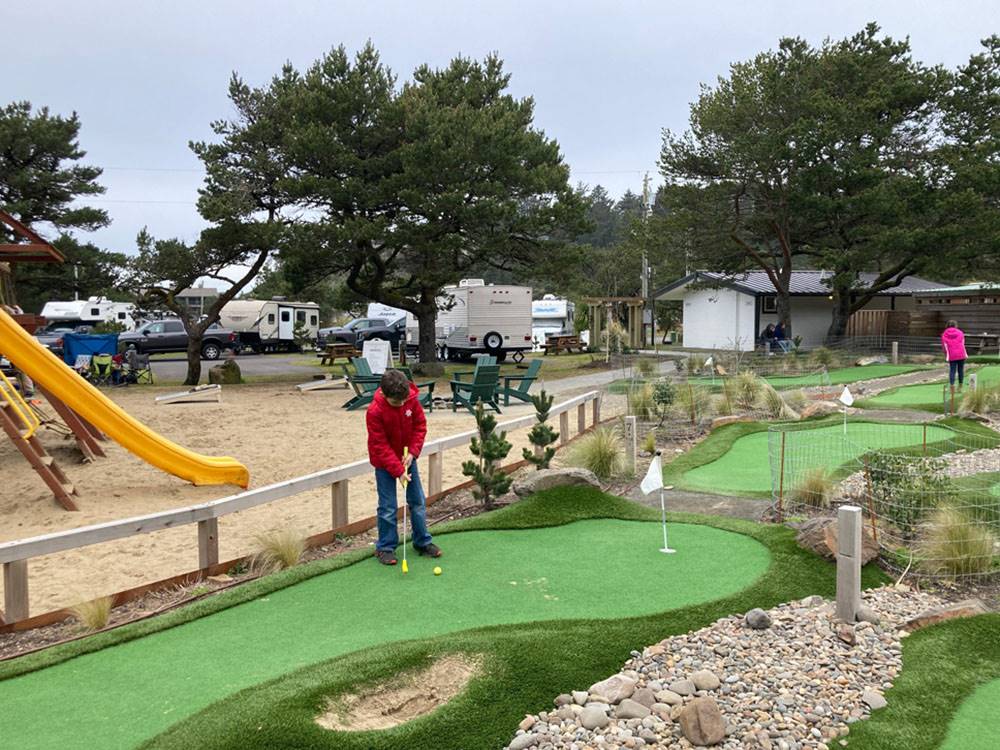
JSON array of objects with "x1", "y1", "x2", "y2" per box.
[{"x1": 768, "y1": 421, "x2": 1000, "y2": 579}]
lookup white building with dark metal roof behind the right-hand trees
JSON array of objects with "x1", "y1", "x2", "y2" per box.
[{"x1": 654, "y1": 271, "x2": 943, "y2": 351}]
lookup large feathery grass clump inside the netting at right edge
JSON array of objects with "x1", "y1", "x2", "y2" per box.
[{"x1": 917, "y1": 507, "x2": 997, "y2": 576}]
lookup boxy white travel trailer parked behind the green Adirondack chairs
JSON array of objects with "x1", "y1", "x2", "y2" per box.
[{"x1": 435, "y1": 279, "x2": 532, "y2": 361}]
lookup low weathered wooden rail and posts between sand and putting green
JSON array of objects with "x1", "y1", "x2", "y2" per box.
[{"x1": 0, "y1": 391, "x2": 602, "y2": 624}]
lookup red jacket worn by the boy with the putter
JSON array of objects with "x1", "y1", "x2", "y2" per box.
[{"x1": 367, "y1": 383, "x2": 427, "y2": 477}]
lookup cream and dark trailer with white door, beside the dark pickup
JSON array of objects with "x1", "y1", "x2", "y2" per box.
[{"x1": 219, "y1": 299, "x2": 319, "y2": 352}]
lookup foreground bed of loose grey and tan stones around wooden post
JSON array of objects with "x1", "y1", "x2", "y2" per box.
[{"x1": 508, "y1": 586, "x2": 941, "y2": 750}]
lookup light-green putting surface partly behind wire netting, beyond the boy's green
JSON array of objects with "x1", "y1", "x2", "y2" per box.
[{"x1": 680, "y1": 422, "x2": 955, "y2": 496}]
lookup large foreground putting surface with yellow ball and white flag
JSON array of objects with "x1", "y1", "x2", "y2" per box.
[{"x1": 0, "y1": 519, "x2": 770, "y2": 748}]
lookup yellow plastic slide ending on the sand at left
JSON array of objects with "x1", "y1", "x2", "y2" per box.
[{"x1": 0, "y1": 309, "x2": 250, "y2": 487}]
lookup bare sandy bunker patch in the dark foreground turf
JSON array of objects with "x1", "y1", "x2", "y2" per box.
[{"x1": 316, "y1": 654, "x2": 482, "y2": 732}]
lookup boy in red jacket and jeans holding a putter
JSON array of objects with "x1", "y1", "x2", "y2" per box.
[{"x1": 367, "y1": 370, "x2": 441, "y2": 565}]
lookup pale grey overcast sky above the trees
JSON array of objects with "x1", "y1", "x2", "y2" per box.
[{"x1": 7, "y1": 0, "x2": 1000, "y2": 251}]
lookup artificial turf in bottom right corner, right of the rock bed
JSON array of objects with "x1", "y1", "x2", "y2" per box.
[{"x1": 847, "y1": 614, "x2": 1000, "y2": 750}]
